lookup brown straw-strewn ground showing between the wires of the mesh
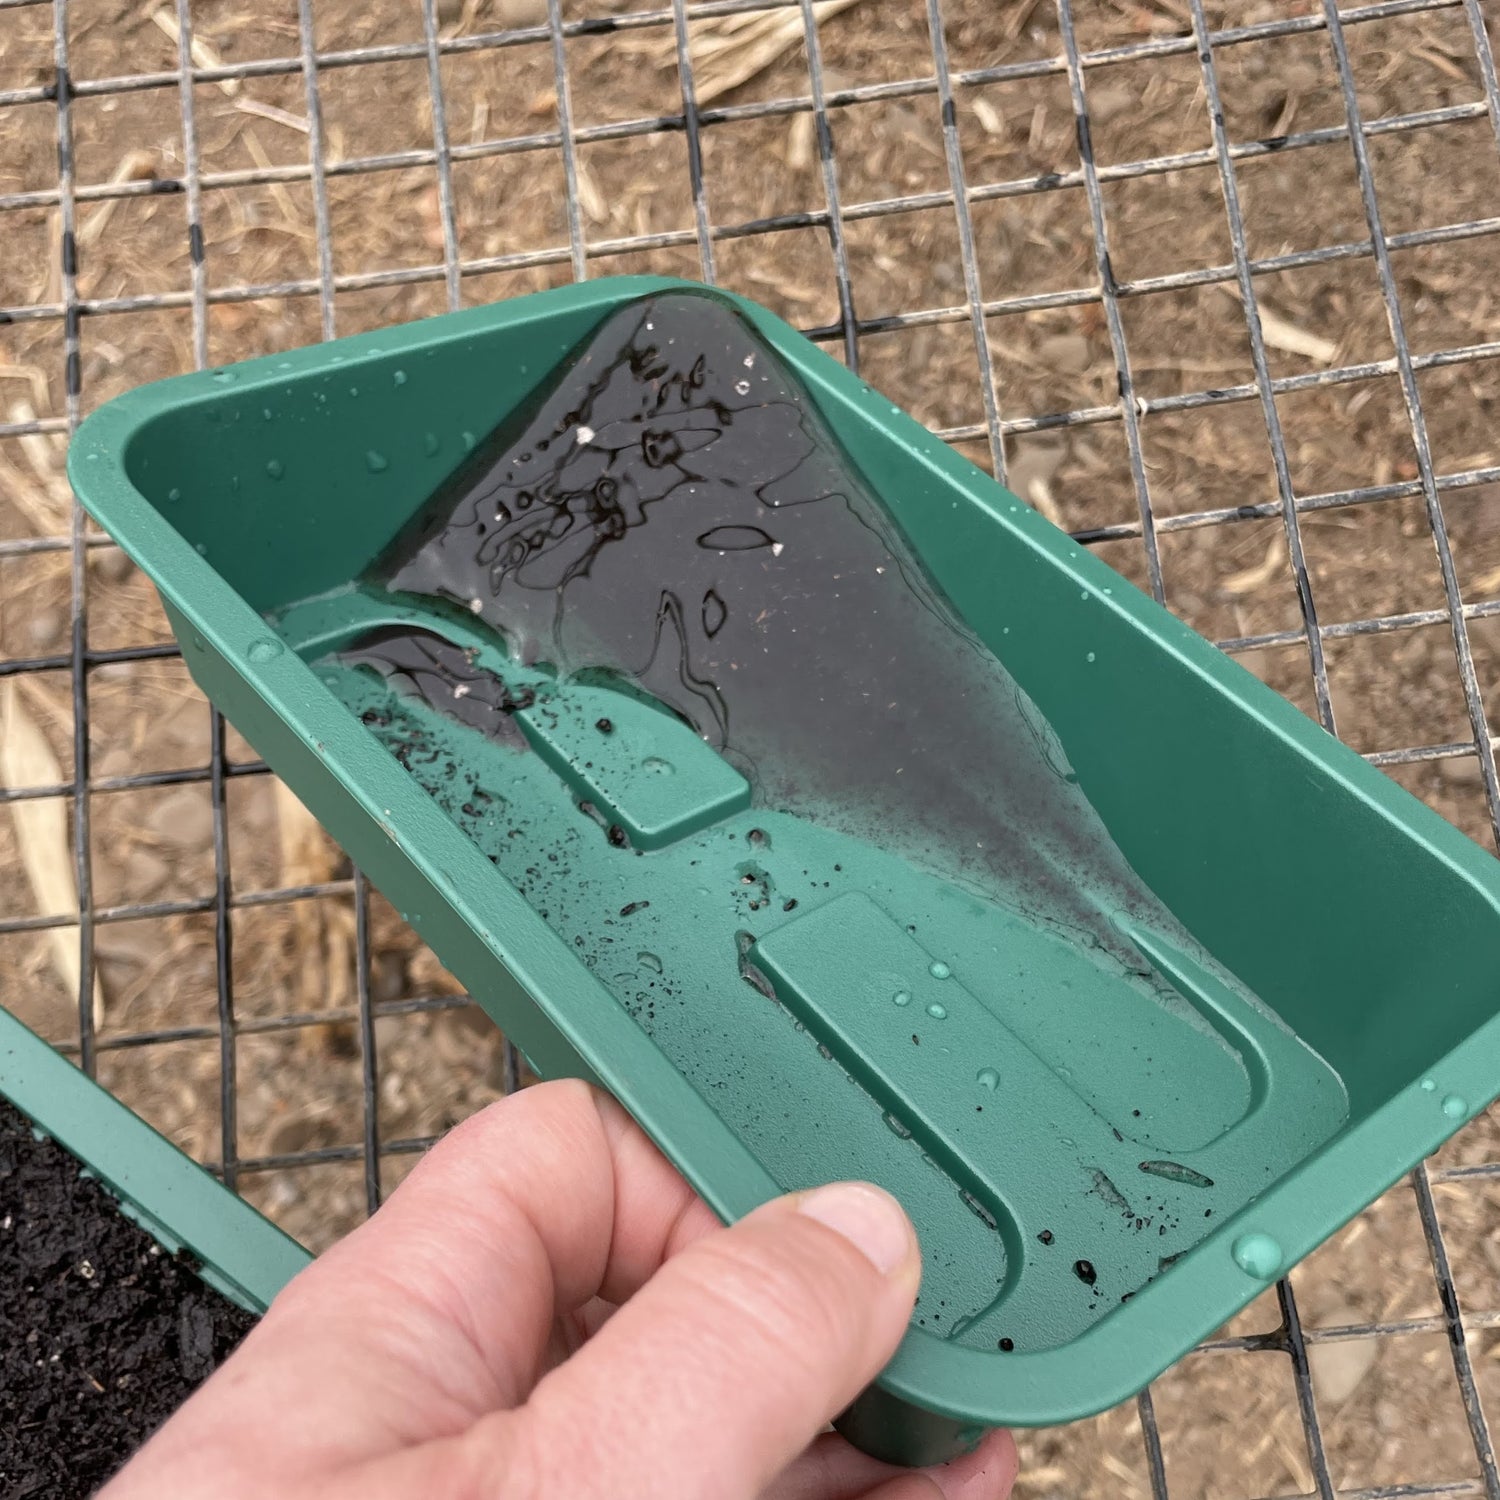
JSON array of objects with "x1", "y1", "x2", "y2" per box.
[{"x1": 0, "y1": 0, "x2": 1500, "y2": 1500}]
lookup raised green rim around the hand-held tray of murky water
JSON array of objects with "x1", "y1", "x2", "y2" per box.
[{"x1": 68, "y1": 276, "x2": 1500, "y2": 1427}]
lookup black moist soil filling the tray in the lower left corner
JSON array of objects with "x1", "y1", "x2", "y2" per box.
[{"x1": 0, "y1": 1100, "x2": 255, "y2": 1500}]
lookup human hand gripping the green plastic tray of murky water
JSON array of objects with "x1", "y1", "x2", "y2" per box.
[{"x1": 99, "y1": 1083, "x2": 1016, "y2": 1500}]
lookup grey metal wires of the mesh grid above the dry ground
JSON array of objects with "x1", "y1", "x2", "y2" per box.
[{"x1": 0, "y1": 0, "x2": 1500, "y2": 1500}]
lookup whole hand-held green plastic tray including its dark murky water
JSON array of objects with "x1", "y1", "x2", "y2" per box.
[{"x1": 72, "y1": 281, "x2": 1500, "y2": 1458}]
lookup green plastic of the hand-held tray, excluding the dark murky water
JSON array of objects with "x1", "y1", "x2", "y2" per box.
[{"x1": 69, "y1": 278, "x2": 1500, "y2": 1463}]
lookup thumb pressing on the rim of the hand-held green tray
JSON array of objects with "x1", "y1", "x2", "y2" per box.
[{"x1": 495, "y1": 1182, "x2": 921, "y2": 1500}]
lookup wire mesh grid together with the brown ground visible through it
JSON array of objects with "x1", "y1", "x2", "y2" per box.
[{"x1": 0, "y1": 0, "x2": 1500, "y2": 1500}]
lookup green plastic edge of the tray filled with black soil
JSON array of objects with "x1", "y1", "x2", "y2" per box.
[{"x1": 0, "y1": 1008, "x2": 312, "y2": 1313}]
